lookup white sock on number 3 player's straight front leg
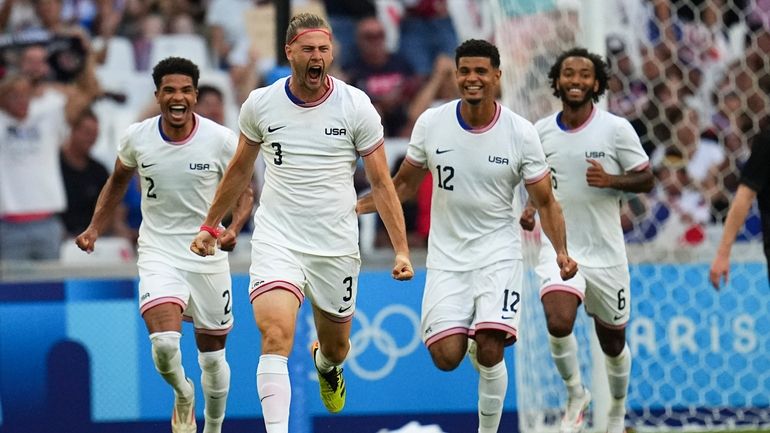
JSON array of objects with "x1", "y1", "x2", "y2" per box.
[{"x1": 257, "y1": 355, "x2": 291, "y2": 433}]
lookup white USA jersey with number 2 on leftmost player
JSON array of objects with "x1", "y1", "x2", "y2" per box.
[{"x1": 118, "y1": 114, "x2": 238, "y2": 273}]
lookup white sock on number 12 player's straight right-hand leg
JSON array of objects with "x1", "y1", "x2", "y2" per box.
[{"x1": 479, "y1": 361, "x2": 508, "y2": 433}]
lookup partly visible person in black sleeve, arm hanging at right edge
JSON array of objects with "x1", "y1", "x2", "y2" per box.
[{"x1": 709, "y1": 128, "x2": 770, "y2": 290}]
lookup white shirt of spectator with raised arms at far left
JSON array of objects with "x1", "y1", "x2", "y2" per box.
[{"x1": 0, "y1": 91, "x2": 69, "y2": 216}]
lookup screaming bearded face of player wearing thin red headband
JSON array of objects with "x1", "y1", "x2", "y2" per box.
[{"x1": 285, "y1": 29, "x2": 333, "y2": 99}]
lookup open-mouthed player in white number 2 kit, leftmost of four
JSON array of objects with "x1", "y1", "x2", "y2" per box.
[{"x1": 75, "y1": 57, "x2": 253, "y2": 433}]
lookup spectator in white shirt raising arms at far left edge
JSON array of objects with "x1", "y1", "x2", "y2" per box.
[{"x1": 0, "y1": 36, "x2": 100, "y2": 260}]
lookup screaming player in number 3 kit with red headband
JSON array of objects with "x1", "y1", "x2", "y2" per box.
[{"x1": 190, "y1": 13, "x2": 414, "y2": 433}]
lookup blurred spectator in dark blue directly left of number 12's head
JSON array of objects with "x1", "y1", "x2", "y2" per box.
[{"x1": 399, "y1": 0, "x2": 458, "y2": 78}]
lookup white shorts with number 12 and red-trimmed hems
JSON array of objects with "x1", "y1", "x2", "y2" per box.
[{"x1": 420, "y1": 260, "x2": 523, "y2": 346}]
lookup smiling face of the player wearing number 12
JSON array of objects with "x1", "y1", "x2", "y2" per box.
[{"x1": 455, "y1": 57, "x2": 500, "y2": 105}]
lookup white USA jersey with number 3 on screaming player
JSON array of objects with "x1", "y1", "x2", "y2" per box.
[{"x1": 239, "y1": 77, "x2": 383, "y2": 256}]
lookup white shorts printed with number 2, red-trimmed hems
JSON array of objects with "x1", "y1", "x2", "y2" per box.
[{"x1": 138, "y1": 261, "x2": 234, "y2": 335}]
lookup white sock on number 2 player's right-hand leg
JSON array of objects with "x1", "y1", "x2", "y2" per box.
[{"x1": 198, "y1": 349, "x2": 230, "y2": 433}]
